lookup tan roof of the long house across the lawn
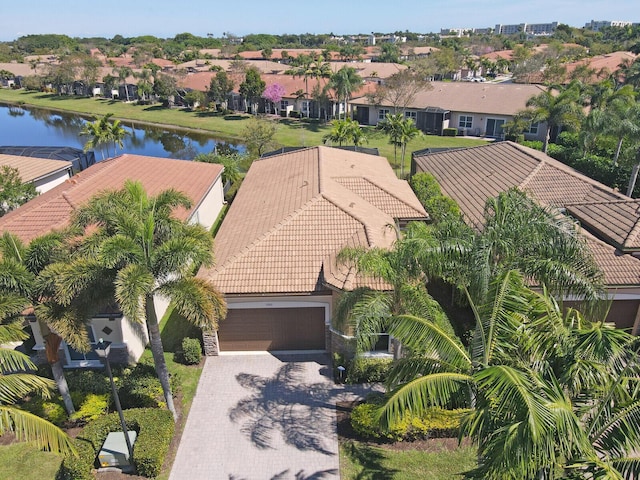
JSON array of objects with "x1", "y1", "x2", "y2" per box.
[{"x1": 351, "y1": 82, "x2": 544, "y2": 115}]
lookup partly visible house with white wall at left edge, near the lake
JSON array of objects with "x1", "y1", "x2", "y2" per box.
[{"x1": 0, "y1": 153, "x2": 73, "y2": 193}]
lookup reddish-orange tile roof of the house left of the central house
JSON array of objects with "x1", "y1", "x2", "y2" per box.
[{"x1": 0, "y1": 154, "x2": 222, "y2": 242}]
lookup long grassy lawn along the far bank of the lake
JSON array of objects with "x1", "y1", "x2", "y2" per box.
[{"x1": 0, "y1": 88, "x2": 487, "y2": 171}]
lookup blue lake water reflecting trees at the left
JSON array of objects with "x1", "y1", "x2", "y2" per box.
[{"x1": 0, "y1": 105, "x2": 244, "y2": 161}]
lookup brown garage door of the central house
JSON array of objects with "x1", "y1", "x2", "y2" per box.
[{"x1": 218, "y1": 307, "x2": 325, "y2": 352}]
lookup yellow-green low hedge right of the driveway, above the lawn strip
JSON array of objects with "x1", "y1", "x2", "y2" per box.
[{"x1": 351, "y1": 402, "x2": 469, "y2": 442}]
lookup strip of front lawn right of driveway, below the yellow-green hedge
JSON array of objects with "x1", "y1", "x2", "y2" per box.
[{"x1": 340, "y1": 440, "x2": 476, "y2": 480}]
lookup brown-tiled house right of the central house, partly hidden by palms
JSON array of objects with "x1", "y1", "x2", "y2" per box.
[{"x1": 412, "y1": 142, "x2": 640, "y2": 334}]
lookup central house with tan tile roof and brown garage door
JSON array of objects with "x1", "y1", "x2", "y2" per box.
[{"x1": 198, "y1": 146, "x2": 428, "y2": 355}]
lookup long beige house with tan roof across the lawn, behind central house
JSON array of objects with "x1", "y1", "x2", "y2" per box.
[{"x1": 349, "y1": 82, "x2": 546, "y2": 140}]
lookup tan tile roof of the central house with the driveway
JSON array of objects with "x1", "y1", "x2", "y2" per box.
[{"x1": 199, "y1": 146, "x2": 427, "y2": 294}]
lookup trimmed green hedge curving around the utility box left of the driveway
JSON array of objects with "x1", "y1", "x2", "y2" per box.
[{"x1": 56, "y1": 408, "x2": 175, "y2": 480}]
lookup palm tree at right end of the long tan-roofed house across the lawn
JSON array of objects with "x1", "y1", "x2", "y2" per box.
[{"x1": 527, "y1": 83, "x2": 582, "y2": 153}]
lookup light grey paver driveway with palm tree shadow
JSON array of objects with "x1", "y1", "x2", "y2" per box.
[{"x1": 169, "y1": 354, "x2": 343, "y2": 480}]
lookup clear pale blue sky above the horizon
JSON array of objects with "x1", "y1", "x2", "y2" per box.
[{"x1": 0, "y1": 0, "x2": 640, "y2": 41}]
